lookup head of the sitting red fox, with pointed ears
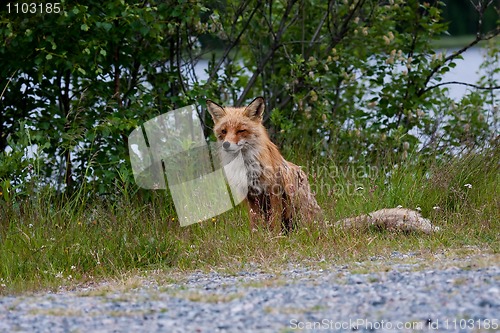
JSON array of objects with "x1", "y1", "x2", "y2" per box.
[{"x1": 207, "y1": 97, "x2": 267, "y2": 153}]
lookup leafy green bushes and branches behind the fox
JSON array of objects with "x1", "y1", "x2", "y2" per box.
[{"x1": 0, "y1": 0, "x2": 500, "y2": 200}]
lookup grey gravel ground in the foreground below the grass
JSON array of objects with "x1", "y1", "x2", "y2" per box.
[{"x1": 0, "y1": 252, "x2": 500, "y2": 333}]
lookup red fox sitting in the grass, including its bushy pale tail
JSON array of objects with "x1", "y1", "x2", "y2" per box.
[{"x1": 207, "y1": 97, "x2": 439, "y2": 233}]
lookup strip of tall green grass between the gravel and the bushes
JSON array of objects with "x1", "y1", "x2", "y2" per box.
[{"x1": 0, "y1": 149, "x2": 500, "y2": 294}]
